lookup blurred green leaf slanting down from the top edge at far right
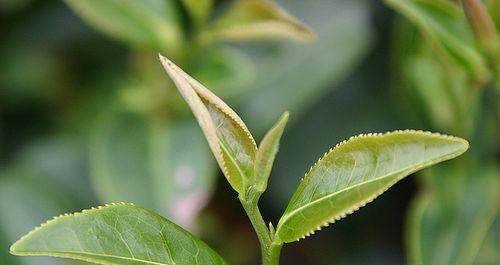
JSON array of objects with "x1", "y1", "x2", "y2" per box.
[{"x1": 385, "y1": 0, "x2": 489, "y2": 81}]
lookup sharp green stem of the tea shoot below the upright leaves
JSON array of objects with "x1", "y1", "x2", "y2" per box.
[{"x1": 238, "y1": 189, "x2": 282, "y2": 265}]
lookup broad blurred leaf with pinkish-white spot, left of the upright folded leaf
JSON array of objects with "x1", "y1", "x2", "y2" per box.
[{"x1": 90, "y1": 111, "x2": 215, "y2": 228}]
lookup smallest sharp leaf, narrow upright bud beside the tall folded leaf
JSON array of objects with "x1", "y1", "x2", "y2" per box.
[{"x1": 255, "y1": 112, "x2": 289, "y2": 192}]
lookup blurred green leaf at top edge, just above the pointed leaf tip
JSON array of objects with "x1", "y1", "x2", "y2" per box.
[{"x1": 65, "y1": 0, "x2": 182, "y2": 54}]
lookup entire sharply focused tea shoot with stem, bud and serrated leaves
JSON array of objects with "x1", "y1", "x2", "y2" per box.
[{"x1": 11, "y1": 56, "x2": 469, "y2": 265}]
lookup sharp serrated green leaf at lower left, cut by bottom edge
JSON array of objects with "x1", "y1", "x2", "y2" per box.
[{"x1": 10, "y1": 204, "x2": 226, "y2": 265}]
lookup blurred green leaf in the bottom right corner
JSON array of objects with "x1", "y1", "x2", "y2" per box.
[{"x1": 408, "y1": 163, "x2": 500, "y2": 265}]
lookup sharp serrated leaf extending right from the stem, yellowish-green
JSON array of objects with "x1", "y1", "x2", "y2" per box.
[{"x1": 276, "y1": 131, "x2": 469, "y2": 242}]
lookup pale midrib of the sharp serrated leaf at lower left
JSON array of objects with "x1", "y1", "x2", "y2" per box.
[{"x1": 12, "y1": 251, "x2": 173, "y2": 265}]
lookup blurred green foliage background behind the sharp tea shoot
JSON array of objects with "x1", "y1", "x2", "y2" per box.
[{"x1": 0, "y1": 0, "x2": 500, "y2": 265}]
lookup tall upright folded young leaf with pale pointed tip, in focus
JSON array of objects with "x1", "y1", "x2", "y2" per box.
[{"x1": 160, "y1": 55, "x2": 257, "y2": 193}]
